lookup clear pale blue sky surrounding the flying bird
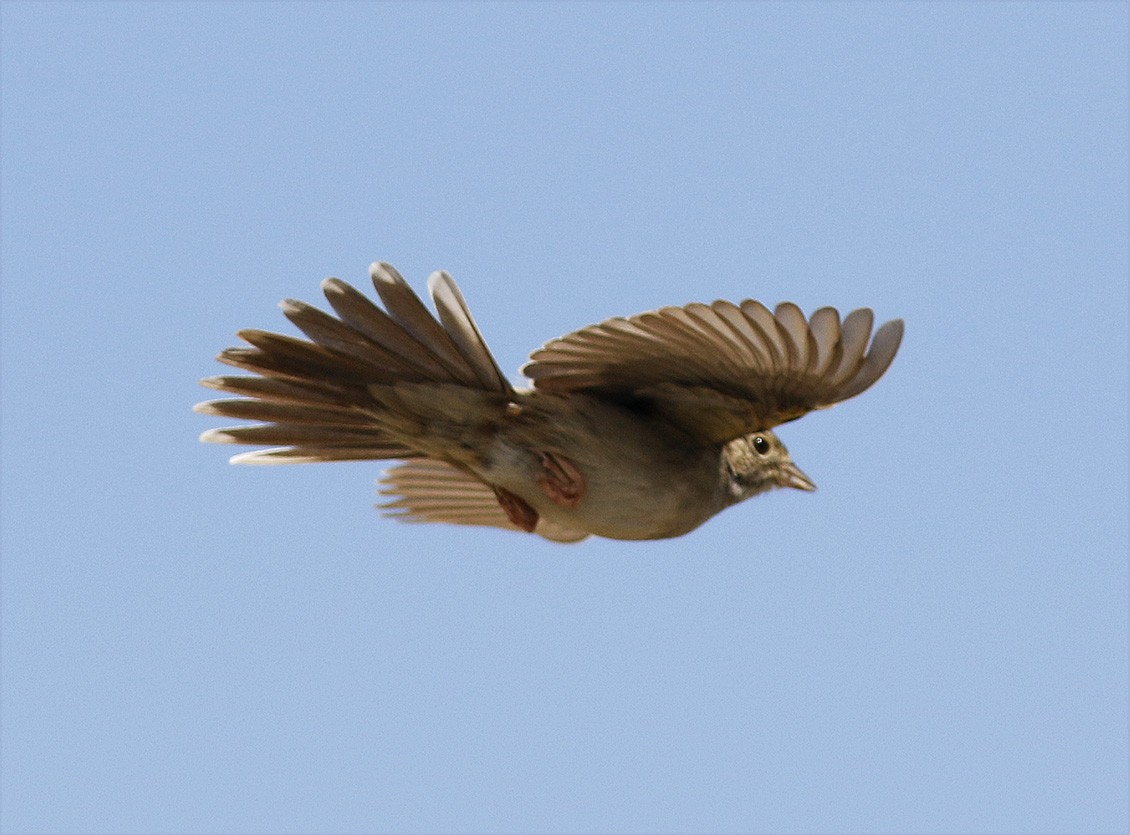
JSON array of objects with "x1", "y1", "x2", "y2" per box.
[{"x1": 0, "y1": 2, "x2": 1130, "y2": 833}]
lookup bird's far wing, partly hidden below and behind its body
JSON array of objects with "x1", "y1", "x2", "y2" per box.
[{"x1": 380, "y1": 459, "x2": 589, "y2": 542}]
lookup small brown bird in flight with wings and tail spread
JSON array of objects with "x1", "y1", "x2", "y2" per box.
[{"x1": 194, "y1": 262, "x2": 903, "y2": 542}]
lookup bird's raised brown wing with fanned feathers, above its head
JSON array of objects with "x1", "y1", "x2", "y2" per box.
[{"x1": 522, "y1": 299, "x2": 903, "y2": 442}]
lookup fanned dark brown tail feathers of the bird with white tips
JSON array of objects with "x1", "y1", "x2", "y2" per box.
[{"x1": 195, "y1": 263, "x2": 513, "y2": 464}]
